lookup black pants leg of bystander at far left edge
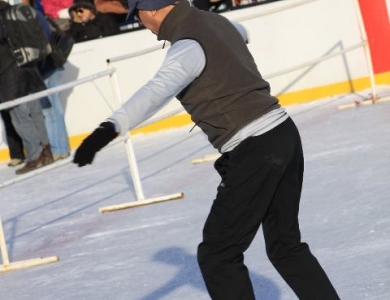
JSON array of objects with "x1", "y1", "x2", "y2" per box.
[{"x1": 1, "y1": 110, "x2": 25, "y2": 160}]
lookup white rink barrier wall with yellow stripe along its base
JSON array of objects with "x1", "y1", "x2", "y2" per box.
[{"x1": 0, "y1": 0, "x2": 388, "y2": 161}]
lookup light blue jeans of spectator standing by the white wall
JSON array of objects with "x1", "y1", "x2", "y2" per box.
[{"x1": 42, "y1": 68, "x2": 70, "y2": 155}]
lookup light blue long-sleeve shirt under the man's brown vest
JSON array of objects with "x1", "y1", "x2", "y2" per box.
[{"x1": 108, "y1": 23, "x2": 288, "y2": 152}]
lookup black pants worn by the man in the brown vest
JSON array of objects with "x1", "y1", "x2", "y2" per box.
[{"x1": 198, "y1": 119, "x2": 339, "y2": 300}]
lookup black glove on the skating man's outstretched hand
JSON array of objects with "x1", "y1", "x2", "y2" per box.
[{"x1": 73, "y1": 122, "x2": 118, "y2": 167}]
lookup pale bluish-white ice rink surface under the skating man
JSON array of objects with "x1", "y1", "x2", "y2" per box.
[{"x1": 0, "y1": 87, "x2": 390, "y2": 300}]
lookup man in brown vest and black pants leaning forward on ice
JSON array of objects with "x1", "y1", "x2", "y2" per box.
[{"x1": 73, "y1": 0, "x2": 339, "y2": 300}]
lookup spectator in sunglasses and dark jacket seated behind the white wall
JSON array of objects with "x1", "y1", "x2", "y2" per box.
[{"x1": 69, "y1": 0, "x2": 120, "y2": 42}]
